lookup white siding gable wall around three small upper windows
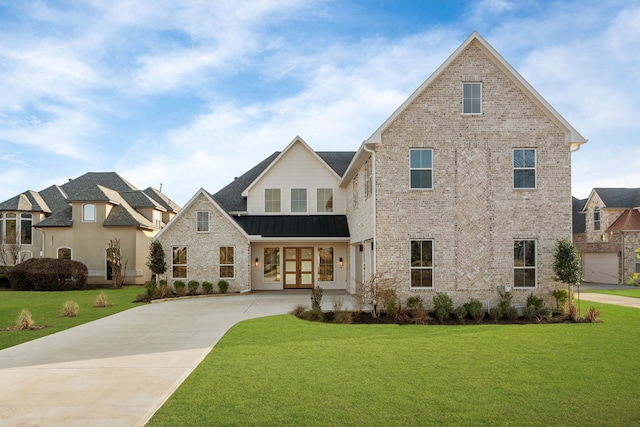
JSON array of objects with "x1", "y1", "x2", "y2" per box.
[{"x1": 247, "y1": 143, "x2": 346, "y2": 215}]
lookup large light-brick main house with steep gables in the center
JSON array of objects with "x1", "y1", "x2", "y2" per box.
[{"x1": 158, "y1": 33, "x2": 586, "y2": 304}]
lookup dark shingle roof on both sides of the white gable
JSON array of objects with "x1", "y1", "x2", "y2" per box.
[{"x1": 212, "y1": 151, "x2": 356, "y2": 216}]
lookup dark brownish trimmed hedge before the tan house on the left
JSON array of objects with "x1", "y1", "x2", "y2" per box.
[{"x1": 7, "y1": 258, "x2": 89, "y2": 291}]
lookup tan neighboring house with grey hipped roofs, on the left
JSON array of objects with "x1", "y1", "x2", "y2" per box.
[{"x1": 0, "y1": 172, "x2": 180, "y2": 284}]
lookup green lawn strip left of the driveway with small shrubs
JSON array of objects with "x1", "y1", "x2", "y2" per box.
[{"x1": 0, "y1": 286, "x2": 145, "y2": 349}]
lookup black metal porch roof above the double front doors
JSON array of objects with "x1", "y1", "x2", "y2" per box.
[{"x1": 233, "y1": 215, "x2": 349, "y2": 238}]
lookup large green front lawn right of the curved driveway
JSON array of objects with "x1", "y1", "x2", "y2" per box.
[{"x1": 149, "y1": 303, "x2": 640, "y2": 426}]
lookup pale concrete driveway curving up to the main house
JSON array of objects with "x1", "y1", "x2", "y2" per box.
[{"x1": 0, "y1": 291, "x2": 353, "y2": 427}]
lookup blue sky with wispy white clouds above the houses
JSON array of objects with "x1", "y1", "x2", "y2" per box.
[{"x1": 0, "y1": 0, "x2": 640, "y2": 205}]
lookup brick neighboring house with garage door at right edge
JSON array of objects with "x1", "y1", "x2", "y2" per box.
[{"x1": 573, "y1": 188, "x2": 640, "y2": 283}]
